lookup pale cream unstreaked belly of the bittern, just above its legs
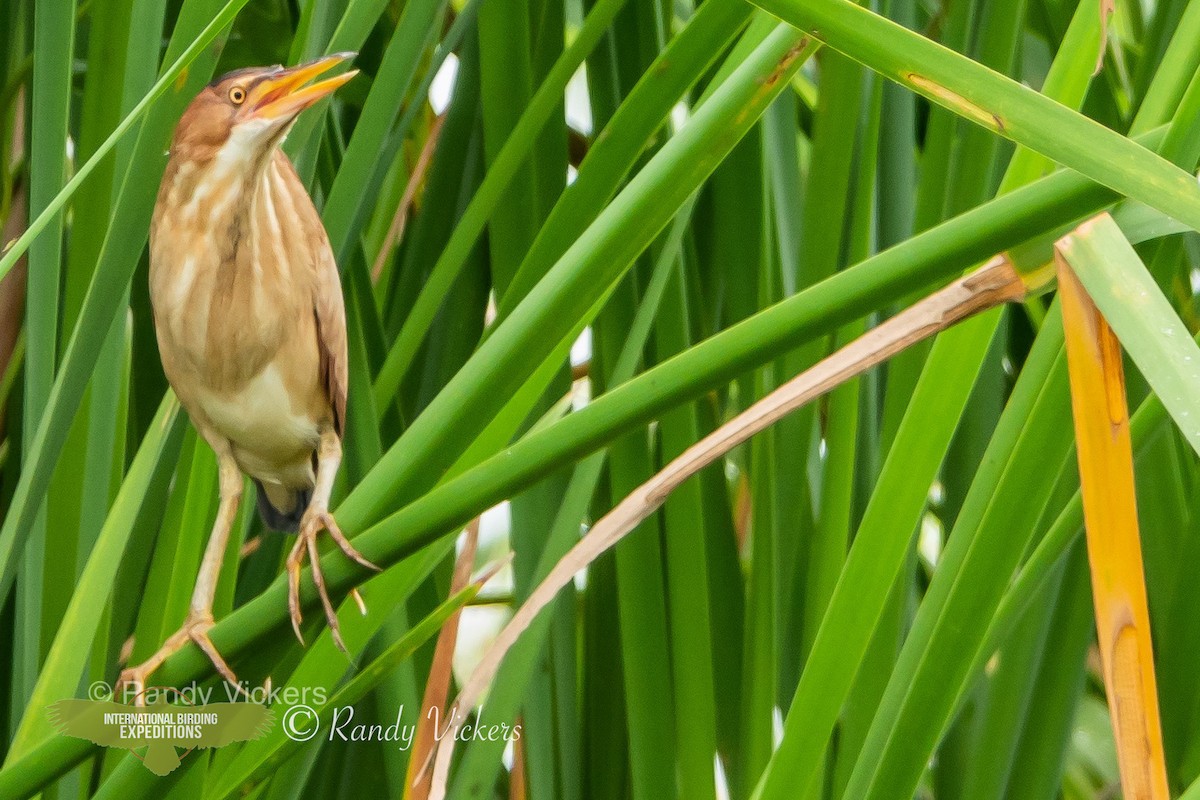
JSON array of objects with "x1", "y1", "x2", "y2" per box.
[{"x1": 196, "y1": 362, "x2": 320, "y2": 487}]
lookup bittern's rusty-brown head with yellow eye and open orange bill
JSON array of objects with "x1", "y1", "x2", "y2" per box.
[{"x1": 172, "y1": 53, "x2": 358, "y2": 166}]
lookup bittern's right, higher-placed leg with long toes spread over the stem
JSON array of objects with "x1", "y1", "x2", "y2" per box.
[{"x1": 288, "y1": 429, "x2": 379, "y2": 652}]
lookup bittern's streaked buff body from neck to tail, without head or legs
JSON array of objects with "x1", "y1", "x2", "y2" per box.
[{"x1": 150, "y1": 142, "x2": 347, "y2": 523}]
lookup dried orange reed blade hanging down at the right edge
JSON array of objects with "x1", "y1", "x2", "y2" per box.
[{"x1": 1055, "y1": 223, "x2": 1170, "y2": 800}]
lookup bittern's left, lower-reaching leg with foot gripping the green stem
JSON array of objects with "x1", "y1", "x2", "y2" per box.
[{"x1": 118, "y1": 444, "x2": 245, "y2": 705}]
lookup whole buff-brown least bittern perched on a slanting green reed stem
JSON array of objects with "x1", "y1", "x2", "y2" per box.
[{"x1": 121, "y1": 53, "x2": 374, "y2": 692}]
